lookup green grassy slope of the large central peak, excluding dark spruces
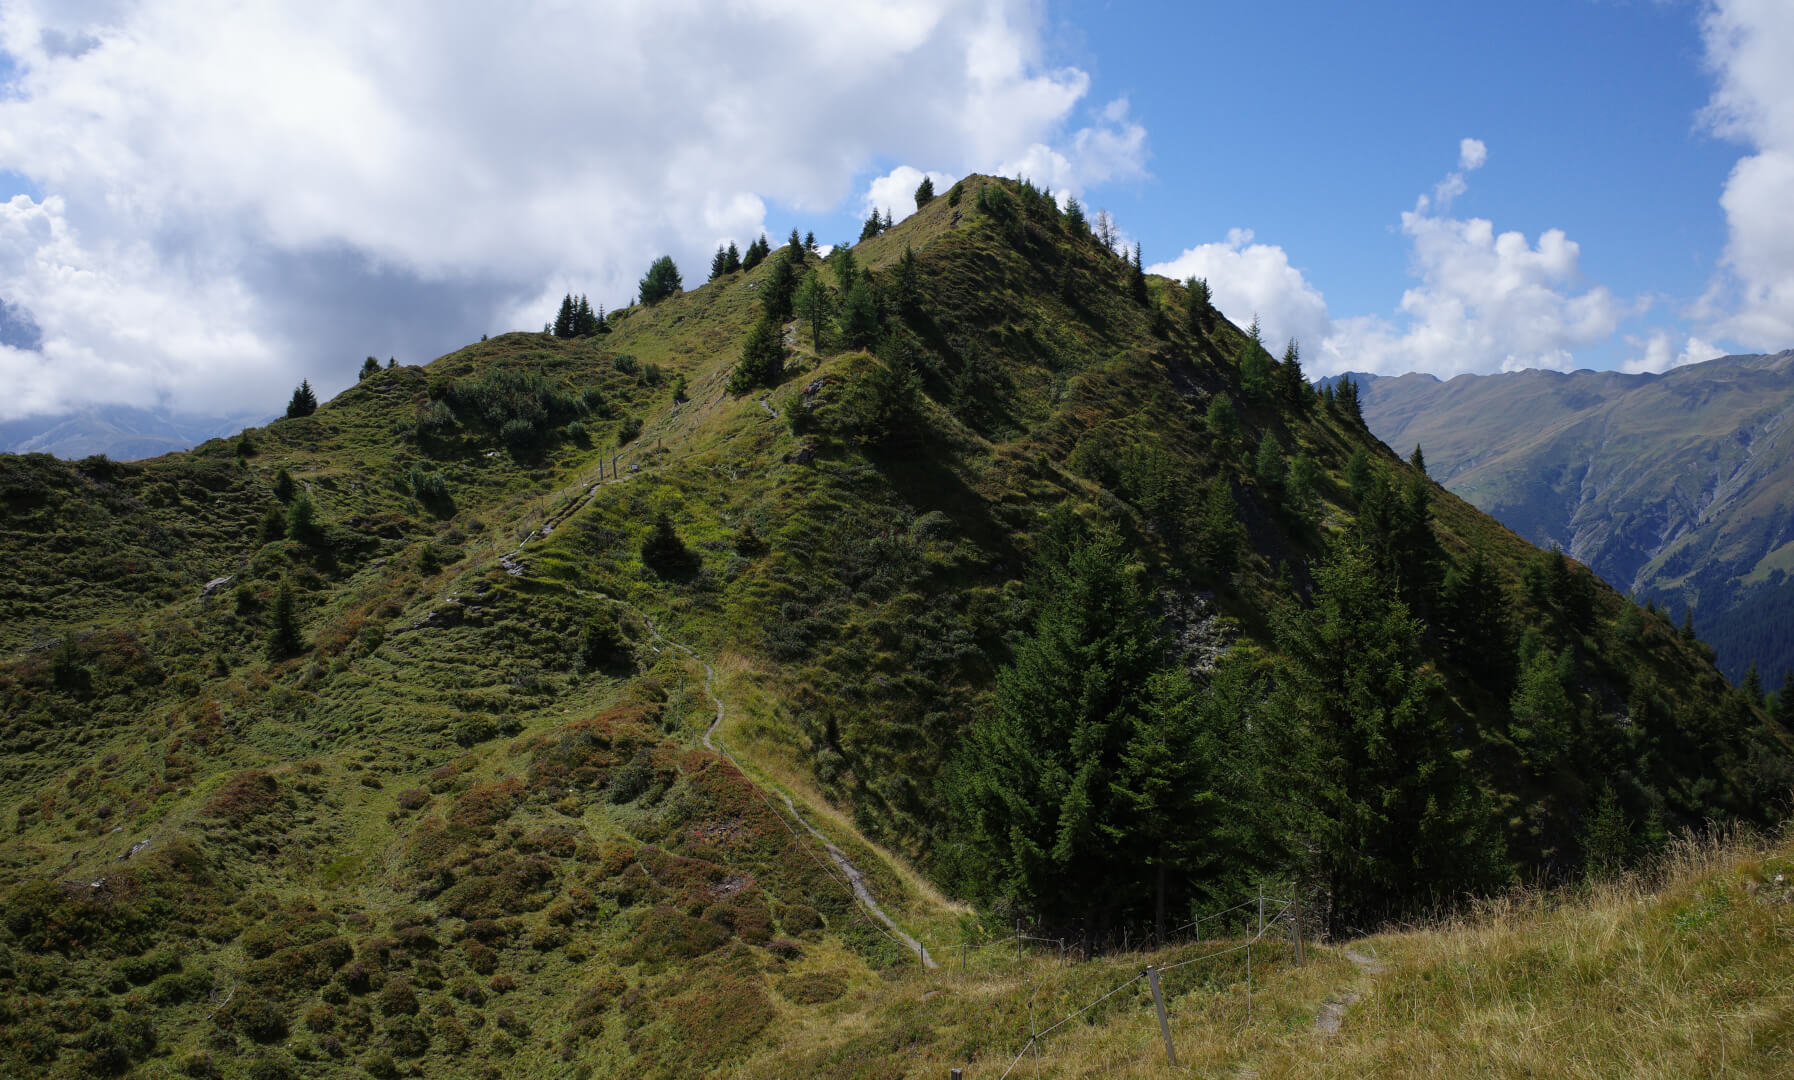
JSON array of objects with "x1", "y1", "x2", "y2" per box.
[{"x1": 0, "y1": 178, "x2": 1787, "y2": 1076}]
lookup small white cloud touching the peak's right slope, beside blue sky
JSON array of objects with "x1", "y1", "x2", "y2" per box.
[{"x1": 1146, "y1": 230, "x2": 1328, "y2": 352}]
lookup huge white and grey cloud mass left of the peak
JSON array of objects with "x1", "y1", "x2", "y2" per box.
[{"x1": 0, "y1": 0, "x2": 1146, "y2": 416}]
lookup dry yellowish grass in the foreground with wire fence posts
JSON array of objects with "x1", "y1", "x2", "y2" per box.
[{"x1": 737, "y1": 825, "x2": 1794, "y2": 1080}]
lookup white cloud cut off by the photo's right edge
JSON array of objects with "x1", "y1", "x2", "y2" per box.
[{"x1": 1697, "y1": 0, "x2": 1794, "y2": 352}]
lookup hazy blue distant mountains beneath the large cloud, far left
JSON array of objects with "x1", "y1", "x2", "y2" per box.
[{"x1": 0, "y1": 405, "x2": 273, "y2": 461}]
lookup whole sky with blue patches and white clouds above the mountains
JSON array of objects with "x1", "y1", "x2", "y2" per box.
[{"x1": 0, "y1": 0, "x2": 1794, "y2": 418}]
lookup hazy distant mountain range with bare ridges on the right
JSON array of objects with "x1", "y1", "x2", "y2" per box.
[{"x1": 1354, "y1": 350, "x2": 1794, "y2": 685}]
